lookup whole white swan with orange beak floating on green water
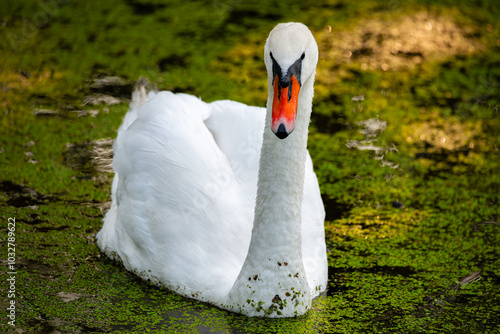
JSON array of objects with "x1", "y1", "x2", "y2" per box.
[{"x1": 97, "y1": 23, "x2": 327, "y2": 317}]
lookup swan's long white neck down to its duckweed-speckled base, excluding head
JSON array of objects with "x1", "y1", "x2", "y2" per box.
[{"x1": 229, "y1": 75, "x2": 314, "y2": 317}]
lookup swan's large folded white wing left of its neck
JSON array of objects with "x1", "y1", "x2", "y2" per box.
[{"x1": 98, "y1": 92, "x2": 256, "y2": 300}]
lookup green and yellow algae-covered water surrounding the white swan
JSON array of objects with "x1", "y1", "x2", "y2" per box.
[{"x1": 0, "y1": 0, "x2": 500, "y2": 333}]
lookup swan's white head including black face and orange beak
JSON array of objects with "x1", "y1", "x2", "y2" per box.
[{"x1": 264, "y1": 23, "x2": 318, "y2": 139}]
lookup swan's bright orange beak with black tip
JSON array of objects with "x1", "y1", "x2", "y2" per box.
[{"x1": 271, "y1": 75, "x2": 300, "y2": 139}]
